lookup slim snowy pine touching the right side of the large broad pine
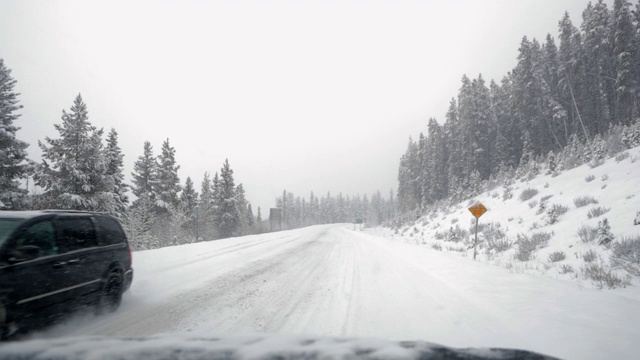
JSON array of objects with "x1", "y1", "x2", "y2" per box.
[{"x1": 105, "y1": 128, "x2": 129, "y2": 218}]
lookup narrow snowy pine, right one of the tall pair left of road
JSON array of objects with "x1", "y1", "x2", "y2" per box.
[{"x1": 156, "y1": 139, "x2": 182, "y2": 212}]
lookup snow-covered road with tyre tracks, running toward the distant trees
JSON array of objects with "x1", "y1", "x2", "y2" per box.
[{"x1": 28, "y1": 225, "x2": 640, "y2": 359}]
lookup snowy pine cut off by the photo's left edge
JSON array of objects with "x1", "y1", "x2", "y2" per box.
[{"x1": 0, "y1": 58, "x2": 29, "y2": 209}]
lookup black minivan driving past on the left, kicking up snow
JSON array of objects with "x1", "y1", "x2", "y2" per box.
[{"x1": 0, "y1": 210, "x2": 133, "y2": 339}]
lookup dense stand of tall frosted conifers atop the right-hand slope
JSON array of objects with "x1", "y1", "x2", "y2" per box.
[{"x1": 398, "y1": 0, "x2": 640, "y2": 214}]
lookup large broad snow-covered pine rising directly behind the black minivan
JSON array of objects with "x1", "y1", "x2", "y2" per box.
[{"x1": 34, "y1": 94, "x2": 113, "y2": 211}]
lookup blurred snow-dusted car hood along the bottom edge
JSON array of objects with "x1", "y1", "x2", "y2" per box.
[{"x1": 0, "y1": 335, "x2": 554, "y2": 360}]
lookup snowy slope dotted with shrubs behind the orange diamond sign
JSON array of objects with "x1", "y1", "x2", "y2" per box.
[{"x1": 370, "y1": 147, "x2": 640, "y2": 288}]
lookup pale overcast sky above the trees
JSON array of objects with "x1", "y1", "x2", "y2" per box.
[{"x1": 0, "y1": 0, "x2": 612, "y2": 214}]
